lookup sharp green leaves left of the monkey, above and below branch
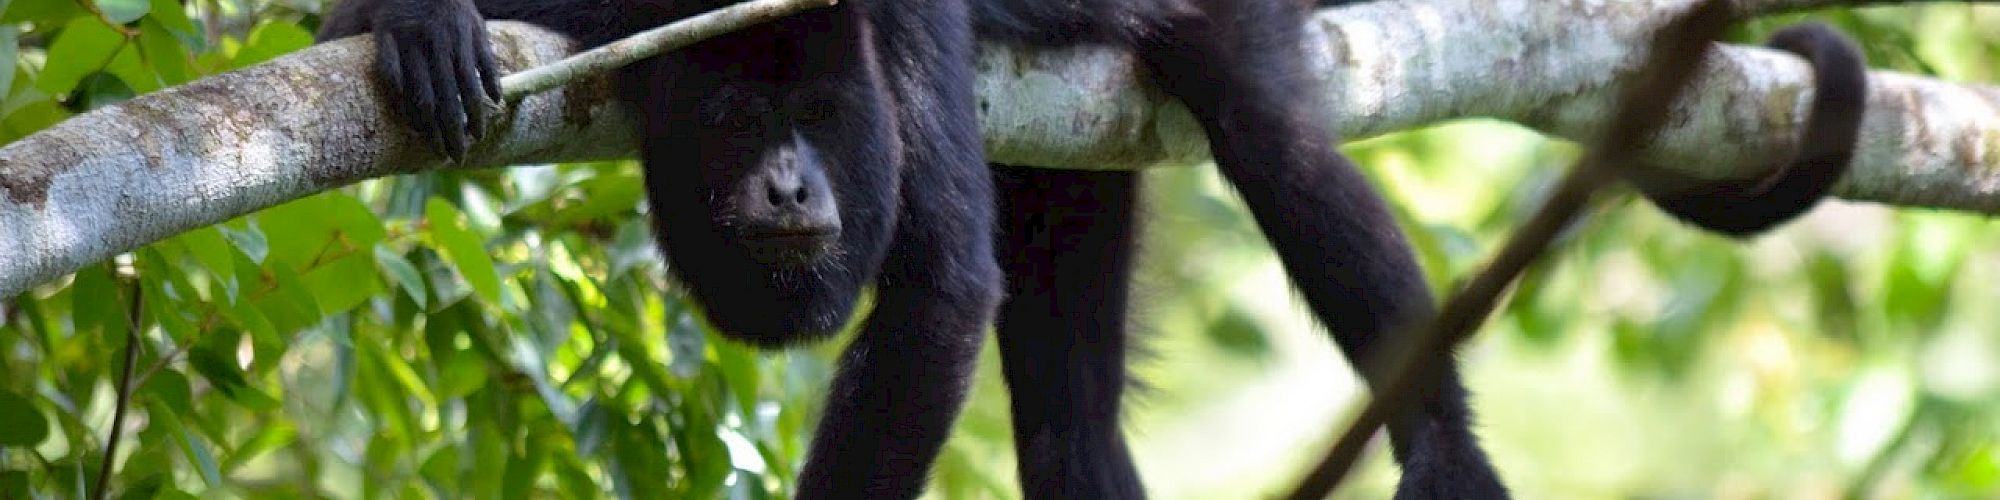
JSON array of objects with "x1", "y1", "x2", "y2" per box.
[{"x1": 0, "y1": 0, "x2": 830, "y2": 498}]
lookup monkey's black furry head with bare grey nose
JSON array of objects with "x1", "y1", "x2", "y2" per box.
[{"x1": 628, "y1": 52, "x2": 900, "y2": 346}]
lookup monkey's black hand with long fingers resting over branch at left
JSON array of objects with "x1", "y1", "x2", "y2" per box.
[{"x1": 320, "y1": 0, "x2": 500, "y2": 160}]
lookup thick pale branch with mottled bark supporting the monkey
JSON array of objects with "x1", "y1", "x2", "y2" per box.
[{"x1": 0, "y1": 0, "x2": 2000, "y2": 296}]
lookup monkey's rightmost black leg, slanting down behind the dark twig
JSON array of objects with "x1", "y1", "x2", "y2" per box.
[{"x1": 1140, "y1": 0, "x2": 1506, "y2": 498}]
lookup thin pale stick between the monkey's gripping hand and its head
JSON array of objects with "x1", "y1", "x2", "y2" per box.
[{"x1": 500, "y1": 0, "x2": 838, "y2": 100}]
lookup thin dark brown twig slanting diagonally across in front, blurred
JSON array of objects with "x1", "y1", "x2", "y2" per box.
[{"x1": 1290, "y1": 2, "x2": 1732, "y2": 498}]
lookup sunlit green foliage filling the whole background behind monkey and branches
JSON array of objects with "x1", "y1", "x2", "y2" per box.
[{"x1": 0, "y1": 0, "x2": 2000, "y2": 498}]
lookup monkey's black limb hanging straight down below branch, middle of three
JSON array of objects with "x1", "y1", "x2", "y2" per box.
[{"x1": 994, "y1": 166, "x2": 1146, "y2": 498}]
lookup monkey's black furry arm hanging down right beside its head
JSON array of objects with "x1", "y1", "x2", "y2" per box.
[{"x1": 798, "y1": 0, "x2": 1002, "y2": 498}]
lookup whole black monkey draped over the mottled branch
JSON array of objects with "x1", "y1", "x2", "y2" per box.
[{"x1": 320, "y1": 0, "x2": 1872, "y2": 498}]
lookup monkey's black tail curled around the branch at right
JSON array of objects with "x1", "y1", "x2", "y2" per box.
[{"x1": 1628, "y1": 24, "x2": 1868, "y2": 238}]
